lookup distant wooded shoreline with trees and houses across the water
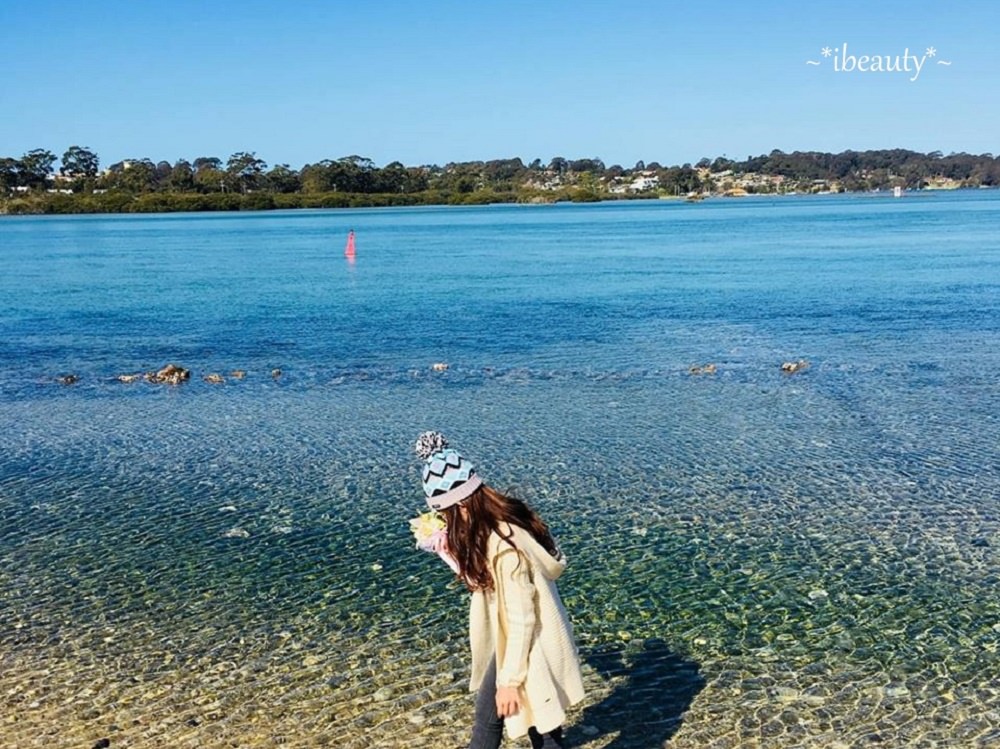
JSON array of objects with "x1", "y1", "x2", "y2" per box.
[{"x1": 0, "y1": 146, "x2": 1000, "y2": 213}]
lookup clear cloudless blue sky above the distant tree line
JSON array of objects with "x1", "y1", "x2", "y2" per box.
[{"x1": 0, "y1": 0, "x2": 1000, "y2": 168}]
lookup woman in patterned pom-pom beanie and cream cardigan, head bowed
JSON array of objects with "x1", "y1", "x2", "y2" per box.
[{"x1": 416, "y1": 432, "x2": 584, "y2": 749}]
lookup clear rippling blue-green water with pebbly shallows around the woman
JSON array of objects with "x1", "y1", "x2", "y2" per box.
[{"x1": 0, "y1": 191, "x2": 1000, "y2": 749}]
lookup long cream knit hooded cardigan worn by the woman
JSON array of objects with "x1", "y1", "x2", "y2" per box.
[{"x1": 469, "y1": 525, "x2": 584, "y2": 738}]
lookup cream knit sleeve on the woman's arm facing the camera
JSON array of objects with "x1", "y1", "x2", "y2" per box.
[{"x1": 494, "y1": 549, "x2": 535, "y2": 687}]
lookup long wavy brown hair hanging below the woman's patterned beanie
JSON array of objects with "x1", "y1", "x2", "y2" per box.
[{"x1": 442, "y1": 484, "x2": 559, "y2": 590}]
